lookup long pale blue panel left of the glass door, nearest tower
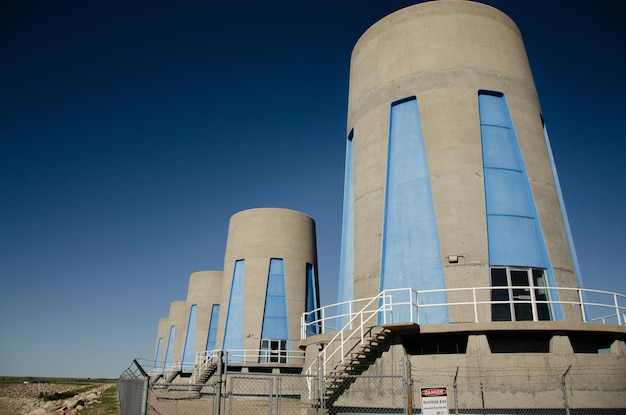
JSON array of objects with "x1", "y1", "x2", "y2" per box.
[{"x1": 380, "y1": 97, "x2": 450, "y2": 324}]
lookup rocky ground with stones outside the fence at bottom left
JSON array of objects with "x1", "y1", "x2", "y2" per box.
[{"x1": 0, "y1": 383, "x2": 114, "y2": 415}]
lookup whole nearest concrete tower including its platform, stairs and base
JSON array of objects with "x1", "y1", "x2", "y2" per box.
[{"x1": 303, "y1": 0, "x2": 626, "y2": 410}]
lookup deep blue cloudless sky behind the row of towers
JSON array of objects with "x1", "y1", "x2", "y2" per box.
[{"x1": 0, "y1": 0, "x2": 626, "y2": 377}]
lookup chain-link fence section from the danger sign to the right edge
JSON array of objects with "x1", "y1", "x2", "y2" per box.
[{"x1": 412, "y1": 364, "x2": 626, "y2": 415}]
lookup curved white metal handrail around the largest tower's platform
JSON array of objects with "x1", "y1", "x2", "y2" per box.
[{"x1": 301, "y1": 286, "x2": 626, "y2": 339}]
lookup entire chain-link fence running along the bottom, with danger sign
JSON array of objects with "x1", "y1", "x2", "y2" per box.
[{"x1": 118, "y1": 362, "x2": 626, "y2": 415}]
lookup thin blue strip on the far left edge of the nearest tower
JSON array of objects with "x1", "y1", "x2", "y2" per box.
[{"x1": 338, "y1": 131, "x2": 354, "y2": 327}]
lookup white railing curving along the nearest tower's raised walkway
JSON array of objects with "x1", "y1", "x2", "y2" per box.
[{"x1": 301, "y1": 286, "x2": 626, "y2": 339}]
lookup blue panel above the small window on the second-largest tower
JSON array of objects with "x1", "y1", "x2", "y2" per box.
[{"x1": 261, "y1": 258, "x2": 289, "y2": 348}]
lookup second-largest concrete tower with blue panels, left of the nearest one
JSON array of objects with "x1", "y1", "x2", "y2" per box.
[{"x1": 218, "y1": 208, "x2": 319, "y2": 363}]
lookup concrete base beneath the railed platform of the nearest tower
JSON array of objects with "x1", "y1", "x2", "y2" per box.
[{"x1": 303, "y1": 322, "x2": 626, "y2": 412}]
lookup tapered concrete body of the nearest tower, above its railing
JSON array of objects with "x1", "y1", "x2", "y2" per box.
[{"x1": 339, "y1": 0, "x2": 579, "y2": 322}]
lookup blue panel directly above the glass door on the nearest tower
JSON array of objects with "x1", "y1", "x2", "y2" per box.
[{"x1": 478, "y1": 91, "x2": 563, "y2": 320}]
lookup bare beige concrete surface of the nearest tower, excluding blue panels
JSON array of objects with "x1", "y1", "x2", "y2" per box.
[{"x1": 348, "y1": 0, "x2": 577, "y2": 316}]
